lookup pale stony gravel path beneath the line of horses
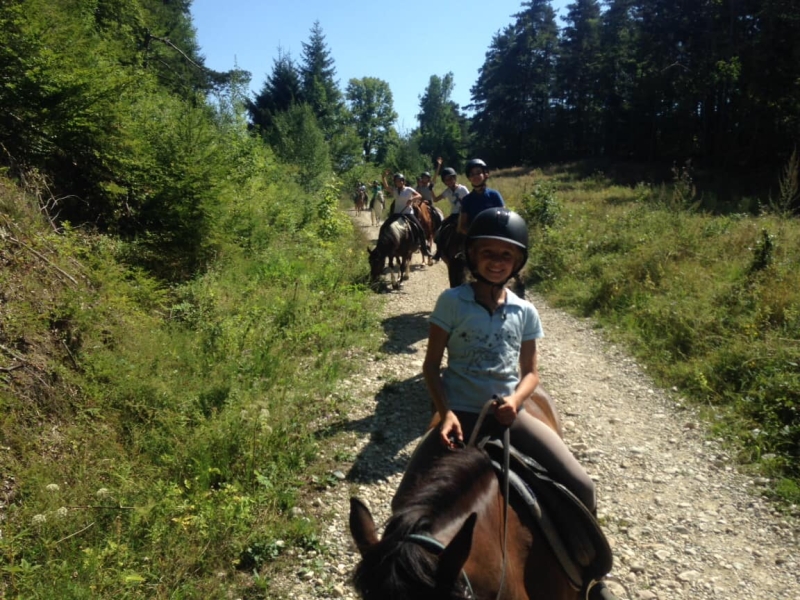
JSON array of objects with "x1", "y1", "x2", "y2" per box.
[{"x1": 275, "y1": 209, "x2": 800, "y2": 600}]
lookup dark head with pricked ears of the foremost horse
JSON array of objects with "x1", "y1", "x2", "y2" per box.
[{"x1": 350, "y1": 498, "x2": 477, "y2": 600}]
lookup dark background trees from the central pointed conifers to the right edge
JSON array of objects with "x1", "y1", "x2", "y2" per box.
[{"x1": 244, "y1": 0, "x2": 800, "y2": 185}]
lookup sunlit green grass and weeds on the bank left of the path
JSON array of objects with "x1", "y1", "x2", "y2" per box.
[{"x1": 0, "y1": 172, "x2": 377, "y2": 598}]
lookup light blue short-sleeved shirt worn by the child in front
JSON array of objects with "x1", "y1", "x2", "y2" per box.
[{"x1": 430, "y1": 283, "x2": 544, "y2": 412}]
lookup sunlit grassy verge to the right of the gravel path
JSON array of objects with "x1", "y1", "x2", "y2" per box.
[{"x1": 494, "y1": 164, "x2": 800, "y2": 504}]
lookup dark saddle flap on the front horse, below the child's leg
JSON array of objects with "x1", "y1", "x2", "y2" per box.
[{"x1": 481, "y1": 439, "x2": 613, "y2": 588}]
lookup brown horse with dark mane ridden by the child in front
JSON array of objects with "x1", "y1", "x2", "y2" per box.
[{"x1": 350, "y1": 390, "x2": 580, "y2": 600}]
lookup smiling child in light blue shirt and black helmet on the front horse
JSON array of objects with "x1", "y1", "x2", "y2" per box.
[{"x1": 393, "y1": 208, "x2": 595, "y2": 528}]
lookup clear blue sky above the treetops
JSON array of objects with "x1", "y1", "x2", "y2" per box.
[{"x1": 192, "y1": 0, "x2": 571, "y2": 133}]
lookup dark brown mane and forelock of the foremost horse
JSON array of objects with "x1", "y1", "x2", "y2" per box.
[{"x1": 353, "y1": 449, "x2": 493, "y2": 600}]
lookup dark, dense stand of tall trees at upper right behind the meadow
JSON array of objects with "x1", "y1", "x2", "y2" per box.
[{"x1": 471, "y1": 0, "x2": 800, "y2": 169}]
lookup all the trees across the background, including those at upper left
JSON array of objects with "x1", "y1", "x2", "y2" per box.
[{"x1": 6, "y1": 0, "x2": 800, "y2": 258}]
